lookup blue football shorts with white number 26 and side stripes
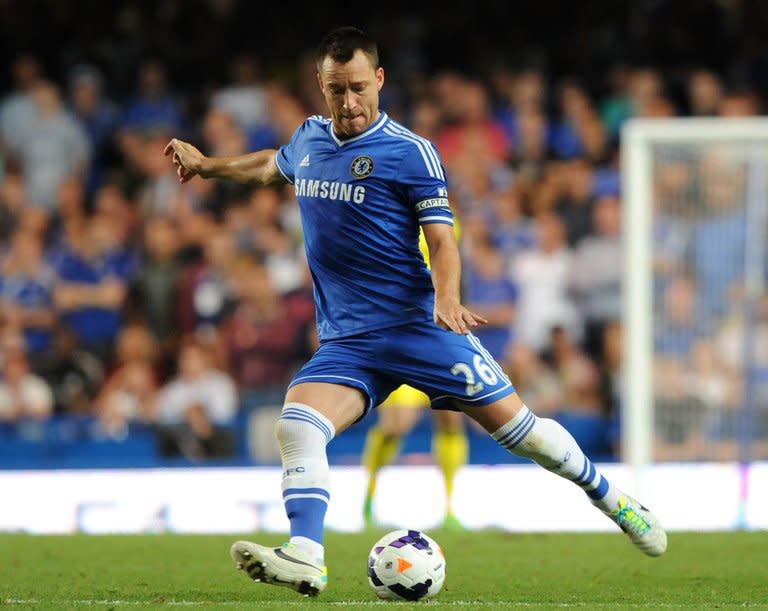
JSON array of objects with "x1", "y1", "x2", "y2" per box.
[{"x1": 289, "y1": 321, "x2": 515, "y2": 412}]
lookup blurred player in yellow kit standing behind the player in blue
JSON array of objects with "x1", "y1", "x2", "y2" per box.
[{"x1": 363, "y1": 222, "x2": 469, "y2": 529}]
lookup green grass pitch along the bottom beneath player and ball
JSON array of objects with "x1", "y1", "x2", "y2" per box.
[{"x1": 0, "y1": 530, "x2": 768, "y2": 611}]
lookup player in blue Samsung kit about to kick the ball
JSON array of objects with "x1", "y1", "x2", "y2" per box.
[{"x1": 166, "y1": 27, "x2": 667, "y2": 596}]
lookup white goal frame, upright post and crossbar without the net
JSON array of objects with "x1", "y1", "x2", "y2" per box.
[{"x1": 621, "y1": 117, "x2": 768, "y2": 469}]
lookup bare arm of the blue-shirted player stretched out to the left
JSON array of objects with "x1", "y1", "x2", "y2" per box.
[{"x1": 165, "y1": 138, "x2": 285, "y2": 186}]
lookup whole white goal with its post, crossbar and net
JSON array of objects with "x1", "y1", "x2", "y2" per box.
[{"x1": 621, "y1": 118, "x2": 768, "y2": 467}]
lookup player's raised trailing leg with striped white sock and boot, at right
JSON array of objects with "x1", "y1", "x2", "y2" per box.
[{"x1": 467, "y1": 394, "x2": 667, "y2": 556}]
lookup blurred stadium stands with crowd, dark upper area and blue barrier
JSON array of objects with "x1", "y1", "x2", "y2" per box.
[{"x1": 0, "y1": 0, "x2": 768, "y2": 536}]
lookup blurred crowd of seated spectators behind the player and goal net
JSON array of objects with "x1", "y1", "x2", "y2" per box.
[{"x1": 0, "y1": 2, "x2": 768, "y2": 457}]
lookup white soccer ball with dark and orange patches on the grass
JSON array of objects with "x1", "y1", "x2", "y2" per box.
[{"x1": 368, "y1": 530, "x2": 445, "y2": 600}]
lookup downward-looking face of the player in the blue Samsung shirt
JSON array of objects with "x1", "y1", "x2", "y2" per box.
[{"x1": 317, "y1": 49, "x2": 384, "y2": 138}]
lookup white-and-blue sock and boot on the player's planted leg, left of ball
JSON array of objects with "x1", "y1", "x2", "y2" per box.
[{"x1": 230, "y1": 403, "x2": 335, "y2": 596}]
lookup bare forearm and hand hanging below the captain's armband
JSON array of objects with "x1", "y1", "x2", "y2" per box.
[{"x1": 422, "y1": 223, "x2": 488, "y2": 335}]
